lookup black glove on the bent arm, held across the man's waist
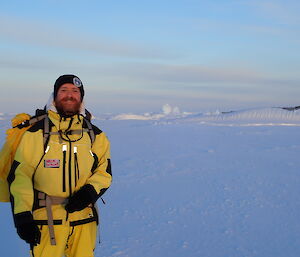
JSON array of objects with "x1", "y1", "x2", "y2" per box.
[{"x1": 65, "y1": 184, "x2": 97, "y2": 213}]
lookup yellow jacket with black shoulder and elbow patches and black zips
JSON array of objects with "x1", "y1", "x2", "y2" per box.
[{"x1": 8, "y1": 110, "x2": 112, "y2": 223}]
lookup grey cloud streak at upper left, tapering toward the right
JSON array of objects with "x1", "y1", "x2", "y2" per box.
[{"x1": 0, "y1": 15, "x2": 177, "y2": 59}]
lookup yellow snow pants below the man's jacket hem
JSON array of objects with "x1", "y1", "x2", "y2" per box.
[{"x1": 31, "y1": 221, "x2": 97, "y2": 257}]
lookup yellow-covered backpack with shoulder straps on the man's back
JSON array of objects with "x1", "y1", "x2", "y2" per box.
[{"x1": 0, "y1": 109, "x2": 95, "y2": 202}]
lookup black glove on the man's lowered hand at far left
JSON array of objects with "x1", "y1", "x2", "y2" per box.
[{"x1": 14, "y1": 211, "x2": 41, "y2": 245}]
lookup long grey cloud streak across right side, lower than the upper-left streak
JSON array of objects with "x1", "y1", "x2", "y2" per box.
[{"x1": 110, "y1": 63, "x2": 300, "y2": 86}]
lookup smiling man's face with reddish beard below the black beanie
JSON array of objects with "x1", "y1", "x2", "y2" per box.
[{"x1": 55, "y1": 83, "x2": 81, "y2": 116}]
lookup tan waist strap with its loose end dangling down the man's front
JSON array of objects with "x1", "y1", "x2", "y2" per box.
[{"x1": 38, "y1": 192, "x2": 68, "y2": 245}]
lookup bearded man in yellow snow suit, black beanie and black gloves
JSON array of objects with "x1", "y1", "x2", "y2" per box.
[{"x1": 7, "y1": 75, "x2": 112, "y2": 257}]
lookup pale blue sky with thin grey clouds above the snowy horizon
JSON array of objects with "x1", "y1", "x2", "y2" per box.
[{"x1": 0, "y1": 0, "x2": 300, "y2": 114}]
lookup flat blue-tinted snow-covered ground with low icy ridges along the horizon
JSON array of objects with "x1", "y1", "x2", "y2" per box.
[{"x1": 0, "y1": 106, "x2": 300, "y2": 257}]
